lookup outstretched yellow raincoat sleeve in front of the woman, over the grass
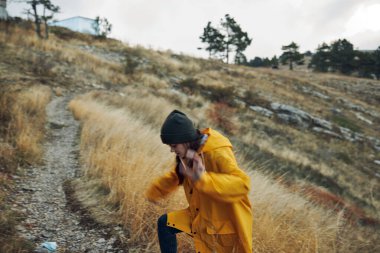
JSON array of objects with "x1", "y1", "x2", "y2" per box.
[{"x1": 145, "y1": 168, "x2": 179, "y2": 201}]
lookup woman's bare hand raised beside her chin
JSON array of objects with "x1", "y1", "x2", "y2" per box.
[{"x1": 179, "y1": 149, "x2": 205, "y2": 182}]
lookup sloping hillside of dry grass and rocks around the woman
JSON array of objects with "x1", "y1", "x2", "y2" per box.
[{"x1": 0, "y1": 20, "x2": 380, "y2": 252}]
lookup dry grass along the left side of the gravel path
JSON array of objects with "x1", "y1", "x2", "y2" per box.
[{"x1": 0, "y1": 86, "x2": 51, "y2": 253}]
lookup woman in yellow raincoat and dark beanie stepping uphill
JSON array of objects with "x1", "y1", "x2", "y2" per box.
[{"x1": 146, "y1": 110, "x2": 252, "y2": 253}]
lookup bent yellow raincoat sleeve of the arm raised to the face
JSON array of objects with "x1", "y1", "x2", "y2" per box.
[{"x1": 195, "y1": 147, "x2": 250, "y2": 202}]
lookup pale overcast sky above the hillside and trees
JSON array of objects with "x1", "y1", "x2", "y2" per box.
[{"x1": 8, "y1": 0, "x2": 380, "y2": 59}]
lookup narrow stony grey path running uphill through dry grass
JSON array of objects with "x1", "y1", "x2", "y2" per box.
[{"x1": 14, "y1": 96, "x2": 124, "y2": 253}]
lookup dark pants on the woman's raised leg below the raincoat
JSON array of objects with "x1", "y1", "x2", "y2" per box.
[{"x1": 157, "y1": 214, "x2": 182, "y2": 253}]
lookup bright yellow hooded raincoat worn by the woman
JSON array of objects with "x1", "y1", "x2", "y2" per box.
[{"x1": 146, "y1": 128, "x2": 252, "y2": 253}]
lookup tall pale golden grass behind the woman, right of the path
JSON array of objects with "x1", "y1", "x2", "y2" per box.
[{"x1": 70, "y1": 92, "x2": 348, "y2": 252}]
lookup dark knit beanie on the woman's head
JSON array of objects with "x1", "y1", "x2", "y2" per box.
[{"x1": 161, "y1": 110, "x2": 199, "y2": 144}]
